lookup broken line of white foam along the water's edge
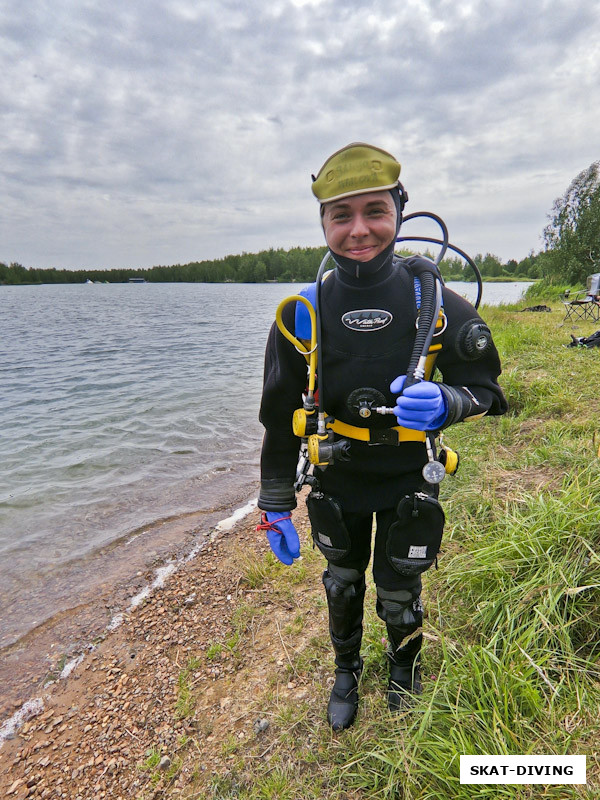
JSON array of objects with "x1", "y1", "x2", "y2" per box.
[{"x1": 0, "y1": 499, "x2": 257, "y2": 748}]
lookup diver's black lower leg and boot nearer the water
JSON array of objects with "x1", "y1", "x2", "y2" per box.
[{"x1": 323, "y1": 565, "x2": 365, "y2": 731}]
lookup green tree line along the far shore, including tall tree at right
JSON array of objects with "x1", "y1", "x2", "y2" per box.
[{"x1": 0, "y1": 161, "x2": 600, "y2": 285}]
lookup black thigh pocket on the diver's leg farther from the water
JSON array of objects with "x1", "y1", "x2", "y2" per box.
[{"x1": 386, "y1": 492, "x2": 446, "y2": 576}]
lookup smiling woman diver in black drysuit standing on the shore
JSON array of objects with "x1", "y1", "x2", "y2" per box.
[{"x1": 258, "y1": 143, "x2": 507, "y2": 730}]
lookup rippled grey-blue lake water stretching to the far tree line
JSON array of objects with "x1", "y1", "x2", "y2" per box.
[{"x1": 0, "y1": 276, "x2": 528, "y2": 708}]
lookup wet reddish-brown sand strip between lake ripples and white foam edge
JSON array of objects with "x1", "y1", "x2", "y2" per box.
[{"x1": 0, "y1": 501, "x2": 254, "y2": 746}]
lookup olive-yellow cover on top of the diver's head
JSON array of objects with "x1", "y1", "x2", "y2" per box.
[{"x1": 312, "y1": 142, "x2": 400, "y2": 203}]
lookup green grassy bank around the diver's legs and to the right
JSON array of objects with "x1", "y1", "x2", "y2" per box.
[{"x1": 161, "y1": 302, "x2": 600, "y2": 800}]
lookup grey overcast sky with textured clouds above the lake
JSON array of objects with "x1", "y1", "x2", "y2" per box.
[{"x1": 0, "y1": 0, "x2": 600, "y2": 269}]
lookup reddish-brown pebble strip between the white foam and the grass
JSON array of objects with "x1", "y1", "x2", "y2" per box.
[{"x1": 0, "y1": 496, "x2": 314, "y2": 800}]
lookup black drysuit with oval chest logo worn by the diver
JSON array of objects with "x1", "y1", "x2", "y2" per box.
[{"x1": 258, "y1": 256, "x2": 507, "y2": 663}]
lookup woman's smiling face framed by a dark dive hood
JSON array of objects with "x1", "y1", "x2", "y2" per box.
[{"x1": 323, "y1": 191, "x2": 396, "y2": 261}]
